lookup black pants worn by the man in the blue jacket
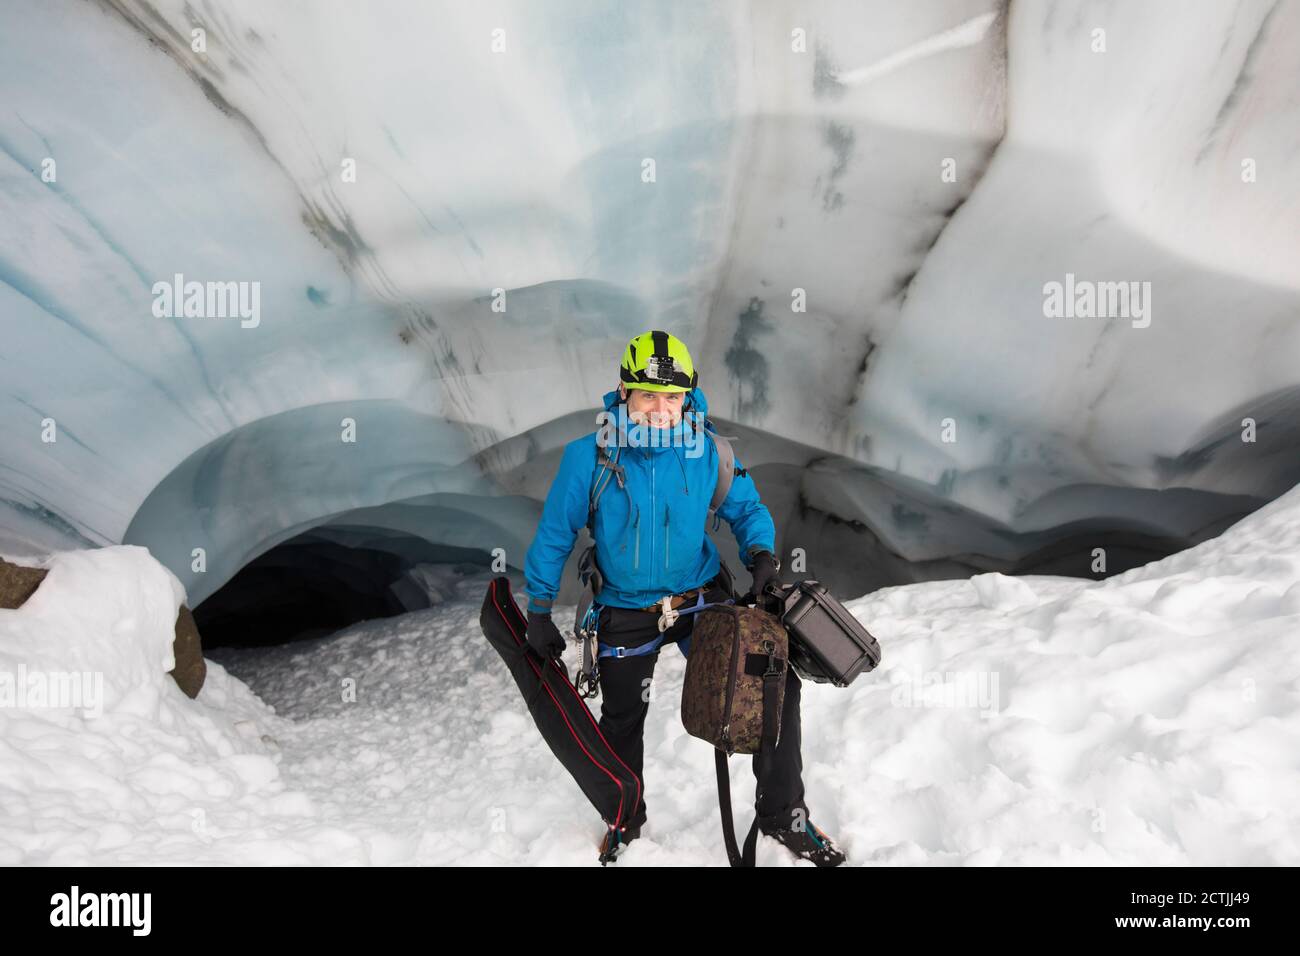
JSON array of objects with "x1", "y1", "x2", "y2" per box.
[{"x1": 599, "y1": 579, "x2": 809, "y2": 827}]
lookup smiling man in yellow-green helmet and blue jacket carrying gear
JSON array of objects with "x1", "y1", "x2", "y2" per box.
[{"x1": 524, "y1": 330, "x2": 844, "y2": 866}]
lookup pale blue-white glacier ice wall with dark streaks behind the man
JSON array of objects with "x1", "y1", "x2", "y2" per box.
[{"x1": 0, "y1": 0, "x2": 1300, "y2": 613}]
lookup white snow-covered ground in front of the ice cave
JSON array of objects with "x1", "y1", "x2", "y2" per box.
[{"x1": 0, "y1": 488, "x2": 1300, "y2": 866}]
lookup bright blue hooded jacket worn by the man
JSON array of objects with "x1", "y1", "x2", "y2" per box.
[{"x1": 524, "y1": 388, "x2": 776, "y2": 611}]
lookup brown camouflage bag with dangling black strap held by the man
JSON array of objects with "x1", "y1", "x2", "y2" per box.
[{"x1": 681, "y1": 605, "x2": 789, "y2": 866}]
